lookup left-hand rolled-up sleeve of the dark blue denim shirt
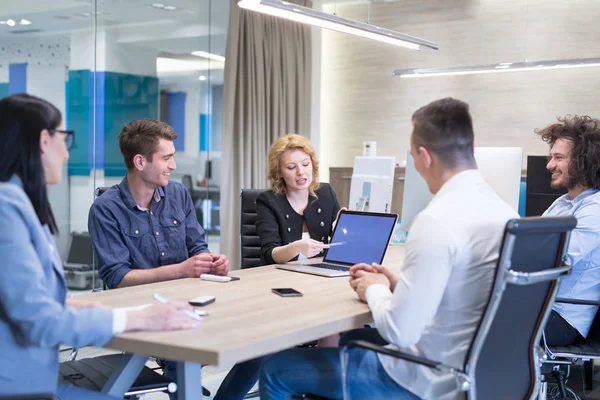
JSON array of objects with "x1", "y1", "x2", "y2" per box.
[{"x1": 88, "y1": 203, "x2": 132, "y2": 289}]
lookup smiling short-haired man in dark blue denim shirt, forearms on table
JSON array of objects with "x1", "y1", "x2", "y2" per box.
[{"x1": 88, "y1": 119, "x2": 229, "y2": 288}]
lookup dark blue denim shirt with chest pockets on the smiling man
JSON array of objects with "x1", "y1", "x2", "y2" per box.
[{"x1": 88, "y1": 177, "x2": 208, "y2": 288}]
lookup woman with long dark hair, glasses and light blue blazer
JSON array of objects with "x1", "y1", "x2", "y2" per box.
[{"x1": 0, "y1": 94, "x2": 202, "y2": 400}]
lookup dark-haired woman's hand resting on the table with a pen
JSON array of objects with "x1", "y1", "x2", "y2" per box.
[{"x1": 125, "y1": 302, "x2": 199, "y2": 332}]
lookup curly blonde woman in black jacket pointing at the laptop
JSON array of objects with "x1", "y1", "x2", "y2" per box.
[{"x1": 256, "y1": 134, "x2": 340, "y2": 264}]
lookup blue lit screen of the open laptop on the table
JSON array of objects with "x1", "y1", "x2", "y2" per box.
[{"x1": 323, "y1": 211, "x2": 398, "y2": 265}]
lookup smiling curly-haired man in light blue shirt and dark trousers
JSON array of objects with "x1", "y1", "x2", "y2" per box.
[{"x1": 536, "y1": 115, "x2": 600, "y2": 346}]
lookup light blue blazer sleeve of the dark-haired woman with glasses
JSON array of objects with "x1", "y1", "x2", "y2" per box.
[{"x1": 0, "y1": 202, "x2": 113, "y2": 348}]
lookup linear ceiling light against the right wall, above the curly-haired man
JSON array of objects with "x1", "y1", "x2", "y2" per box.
[{"x1": 393, "y1": 58, "x2": 600, "y2": 78}]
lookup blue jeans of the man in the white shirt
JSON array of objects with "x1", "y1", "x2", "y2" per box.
[{"x1": 259, "y1": 348, "x2": 419, "y2": 400}]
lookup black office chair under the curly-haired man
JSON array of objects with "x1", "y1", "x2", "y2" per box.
[{"x1": 540, "y1": 297, "x2": 600, "y2": 400}]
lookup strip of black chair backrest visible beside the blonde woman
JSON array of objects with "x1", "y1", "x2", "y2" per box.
[{"x1": 240, "y1": 189, "x2": 264, "y2": 269}]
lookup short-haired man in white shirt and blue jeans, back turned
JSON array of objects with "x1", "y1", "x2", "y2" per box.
[{"x1": 260, "y1": 98, "x2": 518, "y2": 400}]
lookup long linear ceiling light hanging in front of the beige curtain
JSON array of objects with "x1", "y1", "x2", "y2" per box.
[{"x1": 238, "y1": 0, "x2": 438, "y2": 50}]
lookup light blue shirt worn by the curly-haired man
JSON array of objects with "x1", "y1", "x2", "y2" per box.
[{"x1": 543, "y1": 189, "x2": 600, "y2": 337}]
